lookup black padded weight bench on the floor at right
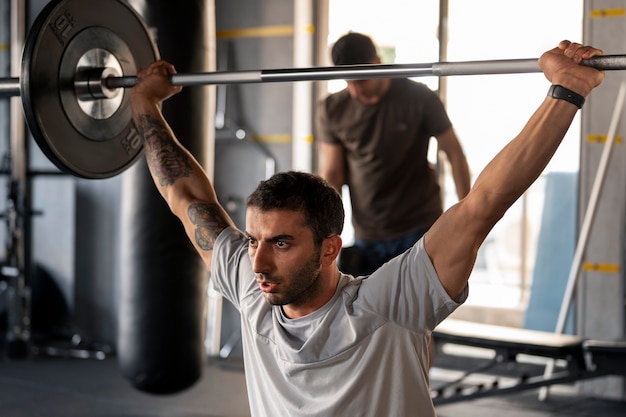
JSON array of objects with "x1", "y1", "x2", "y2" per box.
[{"x1": 431, "y1": 319, "x2": 626, "y2": 405}]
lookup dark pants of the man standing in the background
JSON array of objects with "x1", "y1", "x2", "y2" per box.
[{"x1": 337, "y1": 229, "x2": 428, "y2": 276}]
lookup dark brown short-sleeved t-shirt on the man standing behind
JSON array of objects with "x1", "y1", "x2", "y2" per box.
[{"x1": 316, "y1": 79, "x2": 452, "y2": 240}]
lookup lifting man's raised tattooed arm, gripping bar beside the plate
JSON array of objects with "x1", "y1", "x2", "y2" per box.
[{"x1": 130, "y1": 61, "x2": 234, "y2": 267}]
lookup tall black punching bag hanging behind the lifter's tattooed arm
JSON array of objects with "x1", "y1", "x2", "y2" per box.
[{"x1": 118, "y1": 0, "x2": 215, "y2": 394}]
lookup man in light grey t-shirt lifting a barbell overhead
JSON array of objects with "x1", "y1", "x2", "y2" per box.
[{"x1": 130, "y1": 41, "x2": 604, "y2": 416}]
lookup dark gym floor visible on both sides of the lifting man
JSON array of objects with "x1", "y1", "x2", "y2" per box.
[{"x1": 0, "y1": 348, "x2": 626, "y2": 417}]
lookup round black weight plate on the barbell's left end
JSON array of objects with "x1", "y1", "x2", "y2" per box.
[{"x1": 20, "y1": 0, "x2": 159, "y2": 179}]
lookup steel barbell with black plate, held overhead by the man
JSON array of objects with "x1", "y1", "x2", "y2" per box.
[{"x1": 0, "y1": 0, "x2": 626, "y2": 179}]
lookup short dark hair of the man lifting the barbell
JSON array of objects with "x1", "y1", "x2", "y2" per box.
[{"x1": 247, "y1": 171, "x2": 345, "y2": 246}]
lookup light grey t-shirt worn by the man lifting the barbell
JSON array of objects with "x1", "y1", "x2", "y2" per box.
[{"x1": 211, "y1": 228, "x2": 468, "y2": 417}]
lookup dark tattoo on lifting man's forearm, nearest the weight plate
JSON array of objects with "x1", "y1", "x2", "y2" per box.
[{"x1": 136, "y1": 115, "x2": 191, "y2": 186}]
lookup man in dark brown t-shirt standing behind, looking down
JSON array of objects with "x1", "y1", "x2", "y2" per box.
[{"x1": 316, "y1": 32, "x2": 470, "y2": 275}]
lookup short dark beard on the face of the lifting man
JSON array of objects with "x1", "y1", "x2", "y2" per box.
[{"x1": 264, "y1": 248, "x2": 321, "y2": 306}]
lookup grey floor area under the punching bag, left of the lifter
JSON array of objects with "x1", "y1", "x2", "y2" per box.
[{"x1": 0, "y1": 358, "x2": 250, "y2": 417}]
